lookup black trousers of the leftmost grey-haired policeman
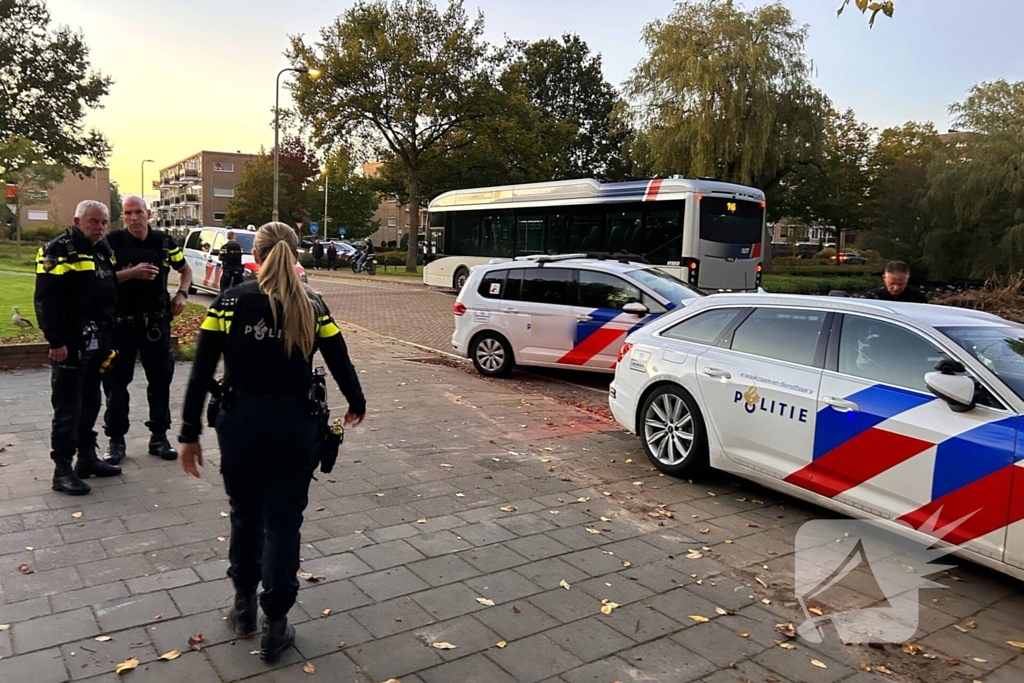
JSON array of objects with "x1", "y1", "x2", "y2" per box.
[{"x1": 50, "y1": 331, "x2": 110, "y2": 463}]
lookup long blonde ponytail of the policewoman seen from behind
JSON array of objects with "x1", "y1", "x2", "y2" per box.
[{"x1": 253, "y1": 222, "x2": 316, "y2": 358}]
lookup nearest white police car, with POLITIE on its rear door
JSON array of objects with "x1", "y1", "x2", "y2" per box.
[{"x1": 609, "y1": 294, "x2": 1024, "y2": 578}]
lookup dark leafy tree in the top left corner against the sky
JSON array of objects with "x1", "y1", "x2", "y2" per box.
[{"x1": 0, "y1": 0, "x2": 112, "y2": 177}]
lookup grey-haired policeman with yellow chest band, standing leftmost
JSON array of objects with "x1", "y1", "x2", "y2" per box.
[{"x1": 35, "y1": 200, "x2": 121, "y2": 496}]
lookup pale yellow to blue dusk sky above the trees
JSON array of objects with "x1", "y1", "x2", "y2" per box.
[{"x1": 48, "y1": 0, "x2": 1024, "y2": 196}]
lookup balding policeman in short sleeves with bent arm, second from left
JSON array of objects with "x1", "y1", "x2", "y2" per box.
[{"x1": 103, "y1": 195, "x2": 191, "y2": 465}]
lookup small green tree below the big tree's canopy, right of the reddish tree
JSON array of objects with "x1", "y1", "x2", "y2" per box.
[{"x1": 306, "y1": 148, "x2": 380, "y2": 240}]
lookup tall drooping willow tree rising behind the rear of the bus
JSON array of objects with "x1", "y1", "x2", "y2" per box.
[{"x1": 627, "y1": 0, "x2": 829, "y2": 189}]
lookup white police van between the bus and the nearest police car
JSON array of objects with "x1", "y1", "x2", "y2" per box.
[{"x1": 452, "y1": 254, "x2": 702, "y2": 377}]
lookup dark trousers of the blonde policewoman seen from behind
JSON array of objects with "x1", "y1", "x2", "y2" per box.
[{"x1": 217, "y1": 393, "x2": 316, "y2": 620}]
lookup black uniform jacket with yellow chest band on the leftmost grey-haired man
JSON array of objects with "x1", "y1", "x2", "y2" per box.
[{"x1": 35, "y1": 227, "x2": 118, "y2": 349}]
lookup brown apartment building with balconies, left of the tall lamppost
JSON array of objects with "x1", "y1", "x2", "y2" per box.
[{"x1": 150, "y1": 151, "x2": 255, "y2": 236}]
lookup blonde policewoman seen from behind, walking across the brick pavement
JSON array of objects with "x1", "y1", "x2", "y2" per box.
[{"x1": 178, "y1": 222, "x2": 367, "y2": 661}]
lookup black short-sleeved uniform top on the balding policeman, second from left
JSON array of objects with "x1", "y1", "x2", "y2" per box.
[{"x1": 106, "y1": 227, "x2": 185, "y2": 317}]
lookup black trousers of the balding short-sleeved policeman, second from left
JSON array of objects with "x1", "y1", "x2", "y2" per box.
[{"x1": 103, "y1": 318, "x2": 174, "y2": 439}]
